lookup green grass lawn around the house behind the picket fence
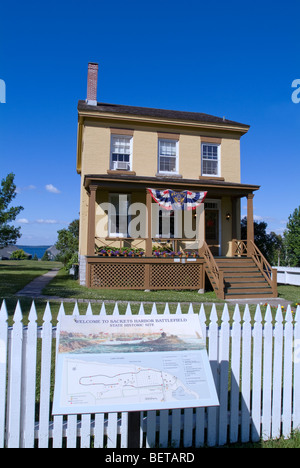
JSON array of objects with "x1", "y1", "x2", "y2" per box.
[{"x1": 0, "y1": 260, "x2": 300, "y2": 324}]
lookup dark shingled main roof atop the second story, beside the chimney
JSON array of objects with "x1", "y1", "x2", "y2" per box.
[{"x1": 78, "y1": 101, "x2": 249, "y2": 129}]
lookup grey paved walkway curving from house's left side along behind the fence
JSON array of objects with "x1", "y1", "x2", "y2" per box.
[{"x1": 16, "y1": 268, "x2": 292, "y2": 309}]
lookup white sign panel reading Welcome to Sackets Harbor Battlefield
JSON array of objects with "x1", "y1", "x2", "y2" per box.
[{"x1": 53, "y1": 314, "x2": 219, "y2": 414}]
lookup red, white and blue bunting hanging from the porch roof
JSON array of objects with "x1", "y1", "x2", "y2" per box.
[{"x1": 148, "y1": 188, "x2": 207, "y2": 210}]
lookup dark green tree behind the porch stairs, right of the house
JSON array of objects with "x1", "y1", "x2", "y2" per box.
[{"x1": 241, "y1": 217, "x2": 283, "y2": 265}]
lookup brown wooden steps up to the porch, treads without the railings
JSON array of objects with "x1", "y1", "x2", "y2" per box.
[{"x1": 215, "y1": 257, "x2": 274, "y2": 299}]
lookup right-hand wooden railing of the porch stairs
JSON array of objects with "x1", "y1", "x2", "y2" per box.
[{"x1": 232, "y1": 239, "x2": 277, "y2": 297}]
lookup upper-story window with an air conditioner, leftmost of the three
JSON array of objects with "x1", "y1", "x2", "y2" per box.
[{"x1": 111, "y1": 135, "x2": 132, "y2": 171}]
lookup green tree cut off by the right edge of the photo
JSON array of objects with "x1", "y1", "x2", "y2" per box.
[{"x1": 284, "y1": 206, "x2": 300, "y2": 267}]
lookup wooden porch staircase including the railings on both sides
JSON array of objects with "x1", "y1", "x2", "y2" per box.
[{"x1": 199, "y1": 240, "x2": 277, "y2": 300}]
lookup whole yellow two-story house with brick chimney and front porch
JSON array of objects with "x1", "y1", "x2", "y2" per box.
[{"x1": 77, "y1": 63, "x2": 276, "y2": 298}]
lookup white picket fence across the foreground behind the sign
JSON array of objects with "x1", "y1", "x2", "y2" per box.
[{"x1": 0, "y1": 302, "x2": 300, "y2": 448}]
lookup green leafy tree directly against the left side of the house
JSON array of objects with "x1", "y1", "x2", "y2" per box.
[{"x1": 55, "y1": 219, "x2": 79, "y2": 268}]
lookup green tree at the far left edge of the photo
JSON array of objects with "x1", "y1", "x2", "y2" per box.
[{"x1": 0, "y1": 172, "x2": 24, "y2": 249}]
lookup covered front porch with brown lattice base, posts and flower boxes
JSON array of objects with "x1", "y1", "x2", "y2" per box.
[{"x1": 80, "y1": 175, "x2": 273, "y2": 298}]
